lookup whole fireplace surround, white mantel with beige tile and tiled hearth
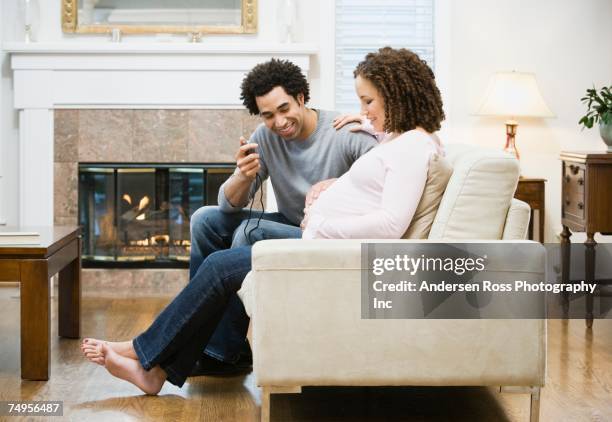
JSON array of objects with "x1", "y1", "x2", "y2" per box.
[{"x1": 3, "y1": 43, "x2": 316, "y2": 296}]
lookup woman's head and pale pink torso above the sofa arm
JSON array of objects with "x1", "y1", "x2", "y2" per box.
[{"x1": 302, "y1": 47, "x2": 444, "y2": 239}]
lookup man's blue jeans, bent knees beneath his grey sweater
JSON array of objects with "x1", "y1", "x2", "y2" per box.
[{"x1": 189, "y1": 206, "x2": 302, "y2": 363}]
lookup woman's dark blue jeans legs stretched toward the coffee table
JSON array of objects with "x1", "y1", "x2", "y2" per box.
[{"x1": 133, "y1": 246, "x2": 251, "y2": 387}]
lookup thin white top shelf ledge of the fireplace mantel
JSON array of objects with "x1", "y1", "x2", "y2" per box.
[{"x1": 2, "y1": 42, "x2": 318, "y2": 56}]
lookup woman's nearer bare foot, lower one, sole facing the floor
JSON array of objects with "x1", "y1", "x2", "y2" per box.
[{"x1": 99, "y1": 343, "x2": 166, "y2": 395}]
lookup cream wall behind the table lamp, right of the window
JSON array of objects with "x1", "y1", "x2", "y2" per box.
[{"x1": 449, "y1": 0, "x2": 612, "y2": 241}]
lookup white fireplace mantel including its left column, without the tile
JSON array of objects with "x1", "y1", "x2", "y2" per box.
[{"x1": 2, "y1": 42, "x2": 317, "y2": 226}]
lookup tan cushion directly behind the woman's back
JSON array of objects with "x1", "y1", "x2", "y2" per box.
[{"x1": 402, "y1": 154, "x2": 453, "y2": 239}]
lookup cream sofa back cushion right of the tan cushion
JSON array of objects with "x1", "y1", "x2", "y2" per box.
[{"x1": 429, "y1": 144, "x2": 519, "y2": 240}]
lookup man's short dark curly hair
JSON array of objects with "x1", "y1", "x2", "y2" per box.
[{"x1": 240, "y1": 59, "x2": 310, "y2": 114}]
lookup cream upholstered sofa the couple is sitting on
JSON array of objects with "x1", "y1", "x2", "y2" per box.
[{"x1": 239, "y1": 145, "x2": 546, "y2": 421}]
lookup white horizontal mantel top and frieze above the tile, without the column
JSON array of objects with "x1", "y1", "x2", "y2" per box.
[{"x1": 3, "y1": 43, "x2": 317, "y2": 110}]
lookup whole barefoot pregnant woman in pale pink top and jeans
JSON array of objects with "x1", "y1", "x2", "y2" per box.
[{"x1": 82, "y1": 47, "x2": 444, "y2": 394}]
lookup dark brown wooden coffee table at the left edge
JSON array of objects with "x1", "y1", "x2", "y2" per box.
[{"x1": 0, "y1": 226, "x2": 81, "y2": 380}]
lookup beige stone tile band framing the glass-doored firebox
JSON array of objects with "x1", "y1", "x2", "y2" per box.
[{"x1": 53, "y1": 109, "x2": 259, "y2": 229}]
